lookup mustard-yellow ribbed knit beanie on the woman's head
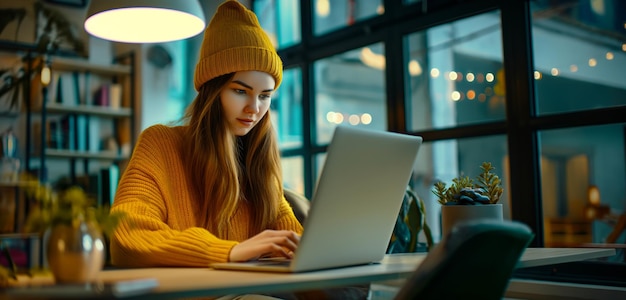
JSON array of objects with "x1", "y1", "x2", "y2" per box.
[{"x1": 194, "y1": 0, "x2": 283, "y2": 90}]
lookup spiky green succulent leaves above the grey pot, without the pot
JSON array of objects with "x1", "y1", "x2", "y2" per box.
[{"x1": 433, "y1": 162, "x2": 503, "y2": 205}]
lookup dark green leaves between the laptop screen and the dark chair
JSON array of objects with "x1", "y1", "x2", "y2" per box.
[{"x1": 387, "y1": 186, "x2": 433, "y2": 253}]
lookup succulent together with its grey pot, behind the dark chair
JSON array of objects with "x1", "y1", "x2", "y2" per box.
[{"x1": 433, "y1": 162, "x2": 503, "y2": 236}]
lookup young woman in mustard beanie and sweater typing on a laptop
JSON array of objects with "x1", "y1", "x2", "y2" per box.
[{"x1": 111, "y1": 1, "x2": 302, "y2": 267}]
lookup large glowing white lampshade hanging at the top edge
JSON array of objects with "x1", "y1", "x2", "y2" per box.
[{"x1": 85, "y1": 0, "x2": 206, "y2": 43}]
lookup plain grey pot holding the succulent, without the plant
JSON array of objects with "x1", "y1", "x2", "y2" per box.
[{"x1": 441, "y1": 204, "x2": 503, "y2": 237}]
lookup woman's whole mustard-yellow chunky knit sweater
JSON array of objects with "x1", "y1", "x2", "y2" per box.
[{"x1": 111, "y1": 125, "x2": 302, "y2": 267}]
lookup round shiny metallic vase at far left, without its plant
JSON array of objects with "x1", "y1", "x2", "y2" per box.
[{"x1": 45, "y1": 222, "x2": 105, "y2": 283}]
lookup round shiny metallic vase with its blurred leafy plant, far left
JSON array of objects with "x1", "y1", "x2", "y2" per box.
[{"x1": 25, "y1": 180, "x2": 123, "y2": 283}]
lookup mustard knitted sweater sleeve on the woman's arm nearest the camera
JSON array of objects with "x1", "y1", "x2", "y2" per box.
[{"x1": 110, "y1": 126, "x2": 237, "y2": 267}]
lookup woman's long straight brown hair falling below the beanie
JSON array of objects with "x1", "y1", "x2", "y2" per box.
[{"x1": 184, "y1": 73, "x2": 283, "y2": 238}]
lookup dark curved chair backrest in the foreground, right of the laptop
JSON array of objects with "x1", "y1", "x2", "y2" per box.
[{"x1": 396, "y1": 220, "x2": 534, "y2": 299}]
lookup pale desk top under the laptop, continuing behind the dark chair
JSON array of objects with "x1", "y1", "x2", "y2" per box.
[{"x1": 0, "y1": 248, "x2": 615, "y2": 299}]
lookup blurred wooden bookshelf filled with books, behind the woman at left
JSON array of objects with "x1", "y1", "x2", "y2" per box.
[{"x1": 26, "y1": 52, "x2": 135, "y2": 204}]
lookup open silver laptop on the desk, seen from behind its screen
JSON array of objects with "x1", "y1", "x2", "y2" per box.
[{"x1": 211, "y1": 126, "x2": 422, "y2": 273}]
